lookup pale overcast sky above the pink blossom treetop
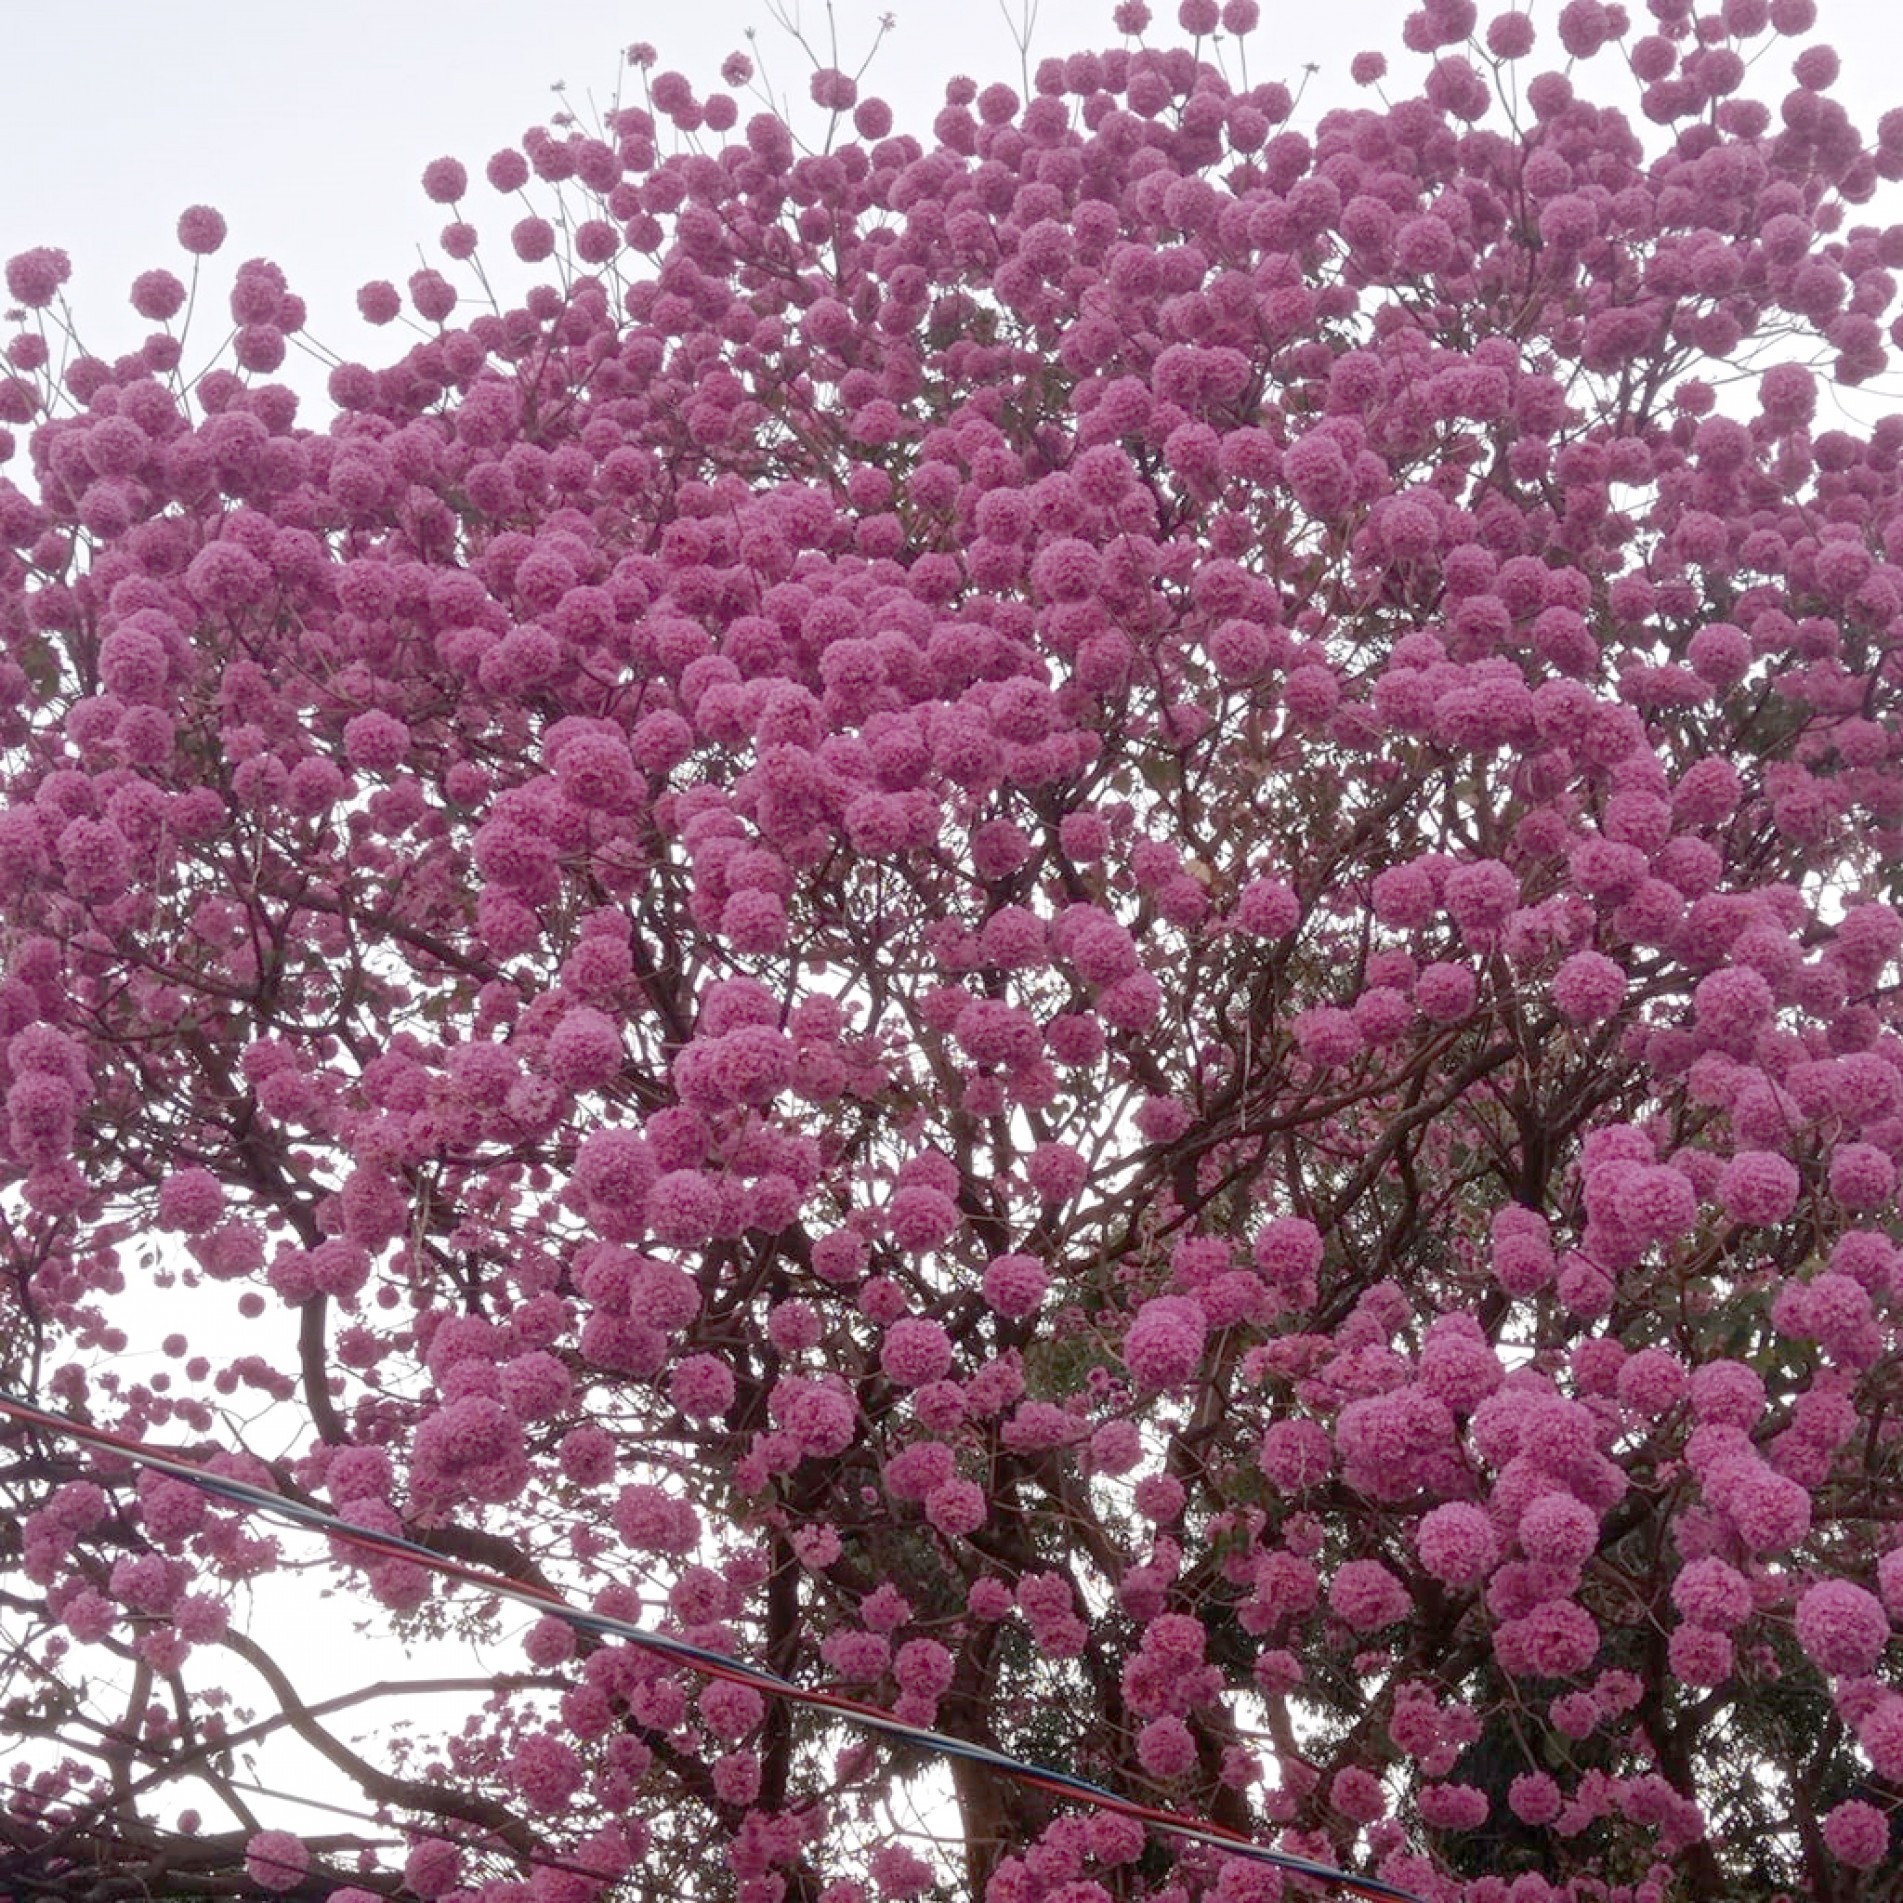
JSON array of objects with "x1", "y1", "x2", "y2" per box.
[{"x1": 0, "y1": 0, "x2": 1903, "y2": 416}]
